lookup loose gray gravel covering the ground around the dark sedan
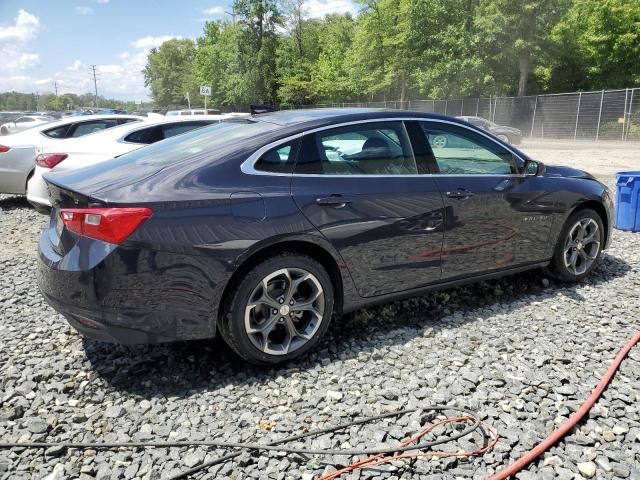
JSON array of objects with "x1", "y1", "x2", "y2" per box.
[{"x1": 0, "y1": 192, "x2": 640, "y2": 480}]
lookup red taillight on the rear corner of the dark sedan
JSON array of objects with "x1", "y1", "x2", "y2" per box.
[{"x1": 60, "y1": 207, "x2": 151, "y2": 245}]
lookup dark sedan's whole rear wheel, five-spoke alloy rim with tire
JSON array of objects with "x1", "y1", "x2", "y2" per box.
[{"x1": 220, "y1": 255, "x2": 333, "y2": 365}]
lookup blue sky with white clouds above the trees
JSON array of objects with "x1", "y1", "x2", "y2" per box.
[{"x1": 0, "y1": 0, "x2": 357, "y2": 100}]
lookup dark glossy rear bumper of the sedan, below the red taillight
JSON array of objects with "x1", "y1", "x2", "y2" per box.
[{"x1": 37, "y1": 228, "x2": 215, "y2": 344}]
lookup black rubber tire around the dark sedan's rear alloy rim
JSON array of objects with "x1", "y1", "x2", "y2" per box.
[{"x1": 218, "y1": 253, "x2": 334, "y2": 366}]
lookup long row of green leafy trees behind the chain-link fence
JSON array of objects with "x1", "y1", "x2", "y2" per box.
[{"x1": 144, "y1": 0, "x2": 640, "y2": 108}]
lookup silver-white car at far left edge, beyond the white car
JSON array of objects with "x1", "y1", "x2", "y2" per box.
[{"x1": 0, "y1": 115, "x2": 141, "y2": 195}]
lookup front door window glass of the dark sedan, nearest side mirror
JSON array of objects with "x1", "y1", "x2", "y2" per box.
[{"x1": 422, "y1": 122, "x2": 518, "y2": 175}]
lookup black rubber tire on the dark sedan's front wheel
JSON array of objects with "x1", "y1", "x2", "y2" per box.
[{"x1": 549, "y1": 208, "x2": 604, "y2": 282}]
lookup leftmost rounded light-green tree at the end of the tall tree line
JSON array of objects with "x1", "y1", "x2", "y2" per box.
[{"x1": 143, "y1": 38, "x2": 198, "y2": 107}]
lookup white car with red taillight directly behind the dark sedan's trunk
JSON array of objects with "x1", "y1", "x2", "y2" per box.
[{"x1": 27, "y1": 115, "x2": 228, "y2": 213}]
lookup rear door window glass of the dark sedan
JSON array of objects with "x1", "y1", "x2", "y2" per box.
[{"x1": 296, "y1": 122, "x2": 417, "y2": 175}]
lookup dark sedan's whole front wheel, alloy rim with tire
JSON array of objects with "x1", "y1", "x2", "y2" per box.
[{"x1": 553, "y1": 209, "x2": 604, "y2": 281}]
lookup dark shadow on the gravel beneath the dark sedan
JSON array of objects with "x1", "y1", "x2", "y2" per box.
[{"x1": 83, "y1": 254, "x2": 631, "y2": 398}]
